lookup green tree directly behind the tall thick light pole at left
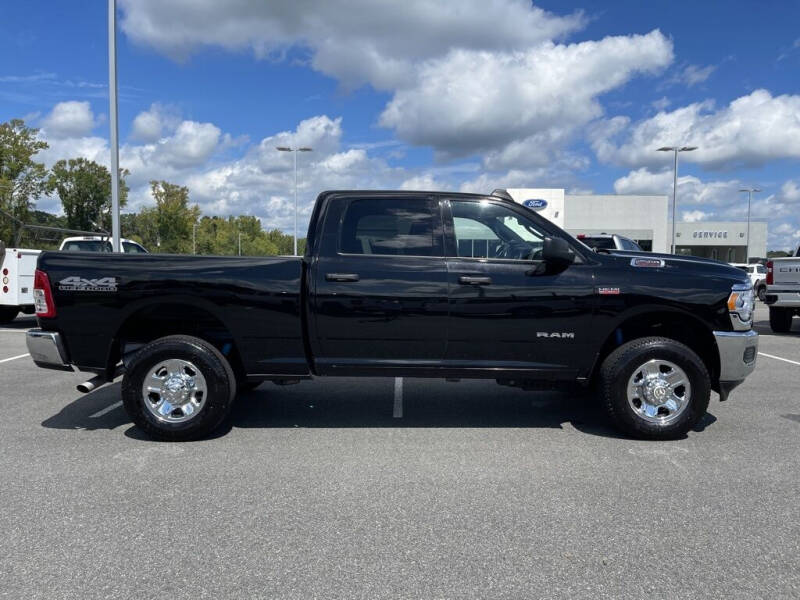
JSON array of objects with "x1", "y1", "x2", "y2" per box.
[{"x1": 47, "y1": 158, "x2": 128, "y2": 231}]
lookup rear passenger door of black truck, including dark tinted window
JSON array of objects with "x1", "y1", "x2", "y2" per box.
[{"x1": 312, "y1": 195, "x2": 448, "y2": 375}]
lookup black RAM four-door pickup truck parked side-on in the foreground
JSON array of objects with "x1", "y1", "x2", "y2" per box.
[{"x1": 27, "y1": 191, "x2": 758, "y2": 440}]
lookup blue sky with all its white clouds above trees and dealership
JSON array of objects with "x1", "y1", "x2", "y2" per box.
[{"x1": 0, "y1": 0, "x2": 800, "y2": 248}]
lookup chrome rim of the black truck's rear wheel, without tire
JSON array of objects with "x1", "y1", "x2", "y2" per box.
[{"x1": 142, "y1": 358, "x2": 208, "y2": 423}]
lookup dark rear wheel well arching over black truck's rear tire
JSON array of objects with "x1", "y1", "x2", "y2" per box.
[{"x1": 107, "y1": 304, "x2": 245, "y2": 377}]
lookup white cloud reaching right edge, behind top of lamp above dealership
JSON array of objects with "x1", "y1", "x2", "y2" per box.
[{"x1": 590, "y1": 90, "x2": 800, "y2": 170}]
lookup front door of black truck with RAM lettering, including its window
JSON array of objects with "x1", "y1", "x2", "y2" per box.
[{"x1": 445, "y1": 198, "x2": 597, "y2": 379}]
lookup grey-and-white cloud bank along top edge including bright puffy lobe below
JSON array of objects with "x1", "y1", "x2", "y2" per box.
[{"x1": 122, "y1": 0, "x2": 673, "y2": 170}]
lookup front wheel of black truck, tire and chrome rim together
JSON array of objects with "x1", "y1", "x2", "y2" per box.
[{"x1": 600, "y1": 337, "x2": 711, "y2": 440}]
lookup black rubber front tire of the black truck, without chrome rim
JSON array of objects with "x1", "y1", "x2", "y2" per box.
[{"x1": 600, "y1": 337, "x2": 711, "y2": 440}]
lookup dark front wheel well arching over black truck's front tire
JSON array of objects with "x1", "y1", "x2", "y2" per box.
[{"x1": 593, "y1": 312, "x2": 720, "y2": 381}]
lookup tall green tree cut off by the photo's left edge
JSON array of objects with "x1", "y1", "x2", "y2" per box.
[{"x1": 0, "y1": 119, "x2": 48, "y2": 243}]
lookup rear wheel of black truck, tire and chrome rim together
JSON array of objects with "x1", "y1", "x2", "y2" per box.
[{"x1": 122, "y1": 335, "x2": 236, "y2": 442}]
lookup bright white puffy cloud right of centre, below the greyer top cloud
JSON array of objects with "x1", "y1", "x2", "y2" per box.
[{"x1": 380, "y1": 31, "x2": 672, "y2": 158}]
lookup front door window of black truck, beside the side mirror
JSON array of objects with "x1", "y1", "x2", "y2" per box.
[{"x1": 451, "y1": 200, "x2": 544, "y2": 260}]
